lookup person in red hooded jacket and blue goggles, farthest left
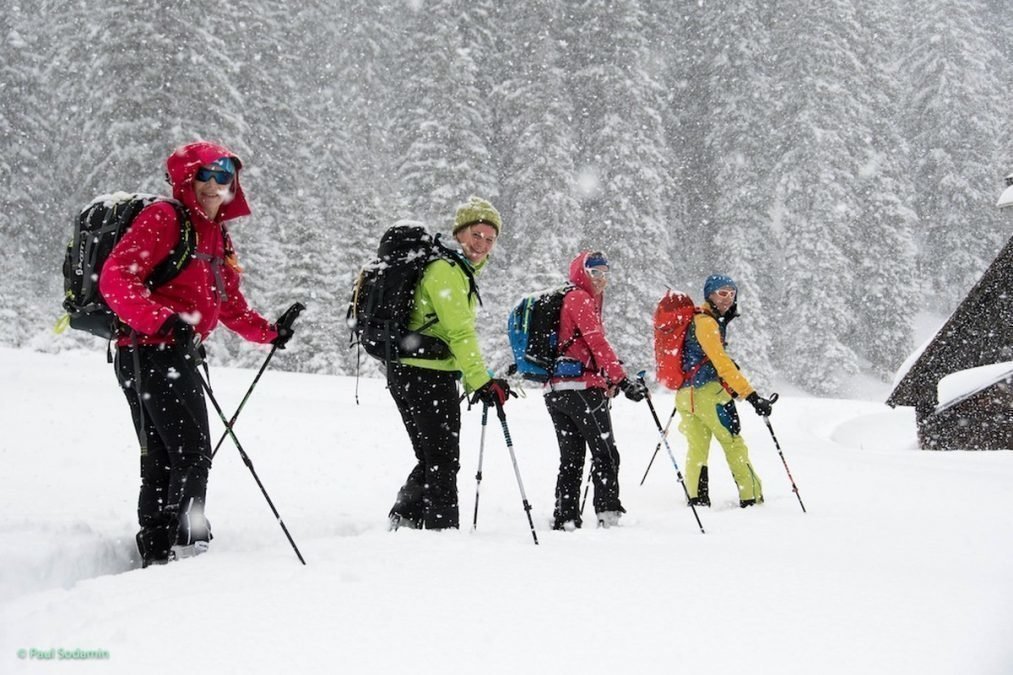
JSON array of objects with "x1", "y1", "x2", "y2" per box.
[{"x1": 98, "y1": 143, "x2": 291, "y2": 567}]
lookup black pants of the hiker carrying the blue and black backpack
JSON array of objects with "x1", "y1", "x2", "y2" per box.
[{"x1": 545, "y1": 388, "x2": 625, "y2": 527}]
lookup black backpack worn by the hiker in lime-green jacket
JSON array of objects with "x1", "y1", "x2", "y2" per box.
[{"x1": 346, "y1": 222, "x2": 481, "y2": 364}]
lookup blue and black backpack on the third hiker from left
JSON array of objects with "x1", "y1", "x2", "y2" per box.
[{"x1": 507, "y1": 284, "x2": 583, "y2": 382}]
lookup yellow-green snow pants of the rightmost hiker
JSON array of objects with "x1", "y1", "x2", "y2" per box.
[{"x1": 676, "y1": 381, "x2": 763, "y2": 502}]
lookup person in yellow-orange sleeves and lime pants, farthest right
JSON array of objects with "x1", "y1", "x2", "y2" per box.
[{"x1": 676, "y1": 275, "x2": 773, "y2": 509}]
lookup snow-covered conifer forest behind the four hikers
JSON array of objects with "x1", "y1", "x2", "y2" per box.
[{"x1": 0, "y1": 0, "x2": 1013, "y2": 394}]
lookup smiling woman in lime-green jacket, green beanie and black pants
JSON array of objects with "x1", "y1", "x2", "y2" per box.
[{"x1": 387, "y1": 197, "x2": 511, "y2": 530}]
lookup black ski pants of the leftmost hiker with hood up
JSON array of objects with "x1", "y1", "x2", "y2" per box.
[{"x1": 115, "y1": 346, "x2": 211, "y2": 563}]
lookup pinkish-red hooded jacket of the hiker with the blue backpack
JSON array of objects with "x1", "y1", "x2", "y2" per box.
[{"x1": 549, "y1": 251, "x2": 626, "y2": 389}]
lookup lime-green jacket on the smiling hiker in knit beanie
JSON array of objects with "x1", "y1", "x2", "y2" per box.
[{"x1": 401, "y1": 251, "x2": 491, "y2": 391}]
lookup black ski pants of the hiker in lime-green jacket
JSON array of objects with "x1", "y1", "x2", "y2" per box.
[{"x1": 387, "y1": 364, "x2": 461, "y2": 530}]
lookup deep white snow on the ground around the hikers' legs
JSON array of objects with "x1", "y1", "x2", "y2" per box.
[{"x1": 0, "y1": 350, "x2": 1013, "y2": 675}]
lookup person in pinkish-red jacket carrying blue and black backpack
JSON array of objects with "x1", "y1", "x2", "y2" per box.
[{"x1": 545, "y1": 251, "x2": 646, "y2": 530}]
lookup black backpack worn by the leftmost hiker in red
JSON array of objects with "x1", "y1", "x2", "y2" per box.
[{"x1": 63, "y1": 193, "x2": 197, "y2": 340}]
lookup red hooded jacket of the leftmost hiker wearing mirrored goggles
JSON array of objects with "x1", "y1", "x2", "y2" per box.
[{"x1": 98, "y1": 142, "x2": 278, "y2": 346}]
